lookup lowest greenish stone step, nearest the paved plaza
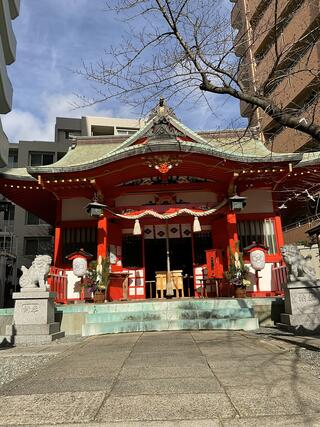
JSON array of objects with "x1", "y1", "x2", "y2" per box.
[{"x1": 82, "y1": 317, "x2": 259, "y2": 336}]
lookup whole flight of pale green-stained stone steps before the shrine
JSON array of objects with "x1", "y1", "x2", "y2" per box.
[{"x1": 82, "y1": 299, "x2": 259, "y2": 336}]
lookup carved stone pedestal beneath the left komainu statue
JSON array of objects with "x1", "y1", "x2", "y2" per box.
[{"x1": 7, "y1": 288, "x2": 64, "y2": 345}]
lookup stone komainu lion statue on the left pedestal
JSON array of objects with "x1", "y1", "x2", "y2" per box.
[{"x1": 19, "y1": 255, "x2": 52, "y2": 290}]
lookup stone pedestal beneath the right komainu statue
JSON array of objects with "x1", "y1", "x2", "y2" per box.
[{"x1": 279, "y1": 280, "x2": 320, "y2": 334}]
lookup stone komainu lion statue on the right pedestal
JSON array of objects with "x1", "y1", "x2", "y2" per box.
[{"x1": 281, "y1": 245, "x2": 317, "y2": 282}]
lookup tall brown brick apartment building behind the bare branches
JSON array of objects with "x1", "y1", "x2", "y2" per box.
[{"x1": 231, "y1": 0, "x2": 320, "y2": 152}]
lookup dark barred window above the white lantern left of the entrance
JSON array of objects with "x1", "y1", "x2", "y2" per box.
[{"x1": 62, "y1": 227, "x2": 97, "y2": 261}]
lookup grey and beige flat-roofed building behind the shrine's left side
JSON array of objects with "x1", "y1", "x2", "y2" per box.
[{"x1": 0, "y1": 117, "x2": 142, "y2": 267}]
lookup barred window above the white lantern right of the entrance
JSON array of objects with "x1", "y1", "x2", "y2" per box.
[{"x1": 238, "y1": 219, "x2": 277, "y2": 254}]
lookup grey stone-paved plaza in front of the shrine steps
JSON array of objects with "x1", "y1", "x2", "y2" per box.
[{"x1": 0, "y1": 331, "x2": 320, "y2": 427}]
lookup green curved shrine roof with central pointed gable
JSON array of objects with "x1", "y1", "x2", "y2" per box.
[{"x1": 2, "y1": 103, "x2": 320, "y2": 179}]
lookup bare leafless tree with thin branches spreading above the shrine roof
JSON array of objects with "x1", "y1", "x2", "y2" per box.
[{"x1": 80, "y1": 0, "x2": 320, "y2": 141}]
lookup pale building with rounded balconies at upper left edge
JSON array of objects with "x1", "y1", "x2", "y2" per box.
[{"x1": 0, "y1": 0, "x2": 20, "y2": 167}]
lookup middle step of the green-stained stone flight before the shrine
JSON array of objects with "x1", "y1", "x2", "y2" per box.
[{"x1": 86, "y1": 307, "x2": 253, "y2": 323}]
